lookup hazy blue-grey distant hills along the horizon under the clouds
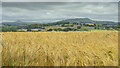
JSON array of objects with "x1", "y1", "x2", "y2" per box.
[{"x1": 2, "y1": 18, "x2": 117, "y2": 25}]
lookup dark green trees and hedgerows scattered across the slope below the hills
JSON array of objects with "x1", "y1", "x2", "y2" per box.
[{"x1": 2, "y1": 22, "x2": 120, "y2": 32}]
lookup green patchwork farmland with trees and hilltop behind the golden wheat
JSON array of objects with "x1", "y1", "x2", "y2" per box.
[{"x1": 0, "y1": 18, "x2": 120, "y2": 32}]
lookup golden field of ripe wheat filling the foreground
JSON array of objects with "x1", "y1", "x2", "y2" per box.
[{"x1": 2, "y1": 31, "x2": 118, "y2": 66}]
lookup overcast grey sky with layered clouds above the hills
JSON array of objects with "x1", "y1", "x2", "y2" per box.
[{"x1": 2, "y1": 0, "x2": 118, "y2": 23}]
